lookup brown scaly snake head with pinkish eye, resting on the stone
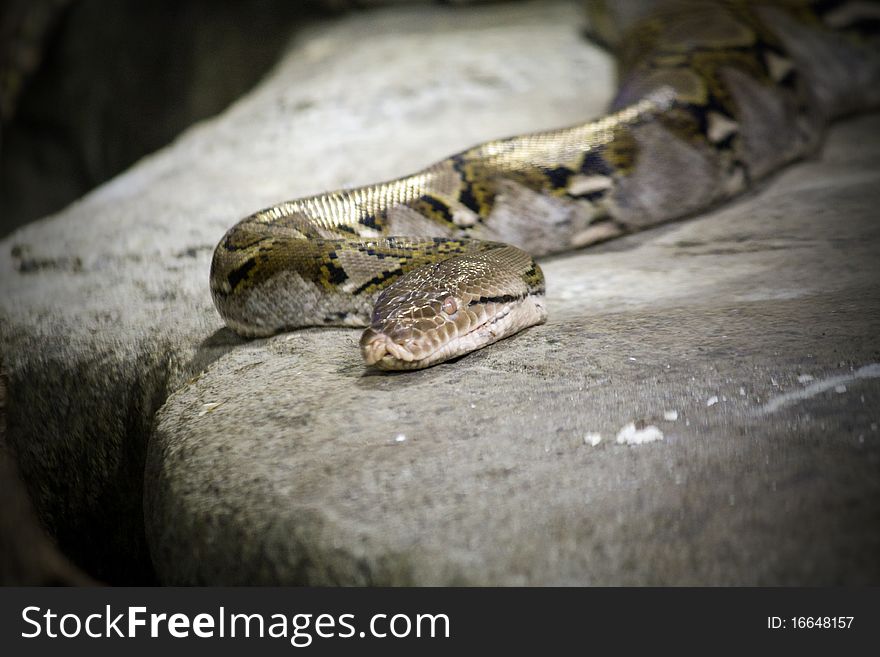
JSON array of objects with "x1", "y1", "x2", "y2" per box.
[{"x1": 360, "y1": 246, "x2": 546, "y2": 370}]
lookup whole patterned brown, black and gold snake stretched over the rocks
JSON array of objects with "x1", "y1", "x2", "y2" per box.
[{"x1": 210, "y1": 0, "x2": 880, "y2": 370}]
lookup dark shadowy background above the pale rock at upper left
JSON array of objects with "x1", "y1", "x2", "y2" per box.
[{"x1": 0, "y1": 0, "x2": 345, "y2": 237}]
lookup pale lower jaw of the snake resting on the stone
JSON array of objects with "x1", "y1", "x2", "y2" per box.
[{"x1": 360, "y1": 294, "x2": 547, "y2": 371}]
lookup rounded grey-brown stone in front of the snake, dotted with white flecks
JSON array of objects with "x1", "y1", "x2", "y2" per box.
[{"x1": 148, "y1": 109, "x2": 880, "y2": 585}]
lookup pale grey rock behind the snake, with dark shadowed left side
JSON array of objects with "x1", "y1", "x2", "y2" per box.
[{"x1": 0, "y1": 3, "x2": 613, "y2": 582}]
